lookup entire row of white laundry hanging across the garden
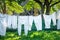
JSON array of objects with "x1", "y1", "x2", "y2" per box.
[{"x1": 0, "y1": 13, "x2": 60, "y2": 35}]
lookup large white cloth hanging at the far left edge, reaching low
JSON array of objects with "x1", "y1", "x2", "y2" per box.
[{"x1": 0, "y1": 15, "x2": 7, "y2": 36}]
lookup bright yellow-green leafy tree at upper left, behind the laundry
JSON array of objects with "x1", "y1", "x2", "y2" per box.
[{"x1": 0, "y1": 0, "x2": 24, "y2": 14}]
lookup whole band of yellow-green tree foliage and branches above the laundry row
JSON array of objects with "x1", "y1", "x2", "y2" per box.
[{"x1": 0, "y1": 0, "x2": 60, "y2": 14}]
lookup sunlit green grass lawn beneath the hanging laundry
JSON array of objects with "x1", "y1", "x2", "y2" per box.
[{"x1": 0, "y1": 30, "x2": 60, "y2": 40}]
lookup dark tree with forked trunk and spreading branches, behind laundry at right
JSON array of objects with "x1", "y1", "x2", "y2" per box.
[{"x1": 34, "y1": 0, "x2": 60, "y2": 15}]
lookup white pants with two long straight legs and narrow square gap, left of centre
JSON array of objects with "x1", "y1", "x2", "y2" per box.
[{"x1": 18, "y1": 16, "x2": 29, "y2": 35}]
